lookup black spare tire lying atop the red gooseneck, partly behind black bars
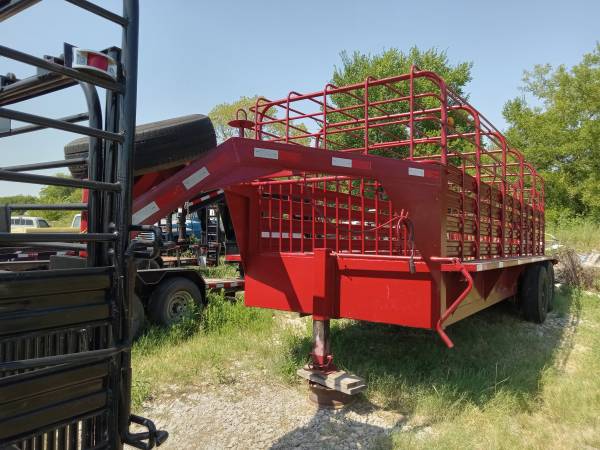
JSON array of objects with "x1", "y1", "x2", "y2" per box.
[{"x1": 65, "y1": 114, "x2": 217, "y2": 178}]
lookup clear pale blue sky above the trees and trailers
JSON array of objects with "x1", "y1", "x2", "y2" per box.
[{"x1": 0, "y1": 0, "x2": 600, "y2": 196}]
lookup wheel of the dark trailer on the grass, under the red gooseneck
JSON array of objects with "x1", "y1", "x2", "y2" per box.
[{"x1": 148, "y1": 277, "x2": 203, "y2": 326}]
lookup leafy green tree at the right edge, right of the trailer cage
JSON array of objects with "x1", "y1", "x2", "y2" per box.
[{"x1": 504, "y1": 43, "x2": 600, "y2": 221}]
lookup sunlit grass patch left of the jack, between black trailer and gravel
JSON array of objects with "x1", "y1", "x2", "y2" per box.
[{"x1": 132, "y1": 293, "x2": 273, "y2": 409}]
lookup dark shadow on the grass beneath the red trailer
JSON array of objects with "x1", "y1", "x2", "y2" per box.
[{"x1": 282, "y1": 290, "x2": 580, "y2": 426}]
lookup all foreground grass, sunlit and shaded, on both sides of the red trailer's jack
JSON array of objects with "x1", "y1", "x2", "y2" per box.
[{"x1": 133, "y1": 290, "x2": 600, "y2": 449}]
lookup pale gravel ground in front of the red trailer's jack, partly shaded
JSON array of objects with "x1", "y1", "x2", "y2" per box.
[{"x1": 142, "y1": 375, "x2": 404, "y2": 450}]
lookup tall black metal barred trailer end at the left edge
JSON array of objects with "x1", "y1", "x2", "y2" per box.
[{"x1": 0, "y1": 0, "x2": 166, "y2": 449}]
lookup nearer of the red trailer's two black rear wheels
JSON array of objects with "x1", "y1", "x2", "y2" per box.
[{"x1": 519, "y1": 264, "x2": 549, "y2": 323}]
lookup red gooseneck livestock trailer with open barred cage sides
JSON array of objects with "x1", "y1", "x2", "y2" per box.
[{"x1": 133, "y1": 67, "x2": 553, "y2": 371}]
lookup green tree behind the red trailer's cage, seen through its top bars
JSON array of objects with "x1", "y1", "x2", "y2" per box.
[{"x1": 328, "y1": 47, "x2": 472, "y2": 157}]
